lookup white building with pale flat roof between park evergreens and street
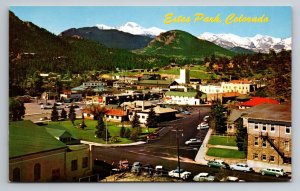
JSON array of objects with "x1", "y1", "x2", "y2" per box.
[{"x1": 128, "y1": 106, "x2": 177, "y2": 124}]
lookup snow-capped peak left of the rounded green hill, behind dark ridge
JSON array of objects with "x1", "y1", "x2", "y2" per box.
[{"x1": 96, "y1": 22, "x2": 166, "y2": 37}]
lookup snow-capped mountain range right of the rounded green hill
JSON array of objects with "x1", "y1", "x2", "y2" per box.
[{"x1": 198, "y1": 32, "x2": 292, "y2": 52}]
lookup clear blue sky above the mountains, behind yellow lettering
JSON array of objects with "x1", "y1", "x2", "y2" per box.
[{"x1": 10, "y1": 6, "x2": 292, "y2": 38}]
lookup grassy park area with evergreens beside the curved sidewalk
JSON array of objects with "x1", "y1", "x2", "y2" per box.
[{"x1": 45, "y1": 120, "x2": 157, "y2": 144}]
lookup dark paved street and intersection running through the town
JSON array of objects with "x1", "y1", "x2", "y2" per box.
[{"x1": 93, "y1": 107, "x2": 289, "y2": 182}]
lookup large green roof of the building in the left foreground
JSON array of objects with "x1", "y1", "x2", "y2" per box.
[{"x1": 9, "y1": 121, "x2": 67, "y2": 158}]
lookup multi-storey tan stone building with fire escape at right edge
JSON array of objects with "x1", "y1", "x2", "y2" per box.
[{"x1": 242, "y1": 103, "x2": 292, "y2": 172}]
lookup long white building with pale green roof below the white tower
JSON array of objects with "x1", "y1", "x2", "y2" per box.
[{"x1": 164, "y1": 91, "x2": 200, "y2": 105}]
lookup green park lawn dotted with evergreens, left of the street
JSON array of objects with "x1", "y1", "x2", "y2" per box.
[{"x1": 46, "y1": 120, "x2": 155, "y2": 144}]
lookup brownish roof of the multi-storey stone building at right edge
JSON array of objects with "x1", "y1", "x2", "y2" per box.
[{"x1": 244, "y1": 103, "x2": 292, "y2": 122}]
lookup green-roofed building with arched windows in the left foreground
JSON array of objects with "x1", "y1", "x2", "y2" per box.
[{"x1": 9, "y1": 121, "x2": 92, "y2": 182}]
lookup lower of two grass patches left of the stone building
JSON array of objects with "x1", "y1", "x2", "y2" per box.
[{"x1": 206, "y1": 148, "x2": 246, "y2": 159}]
